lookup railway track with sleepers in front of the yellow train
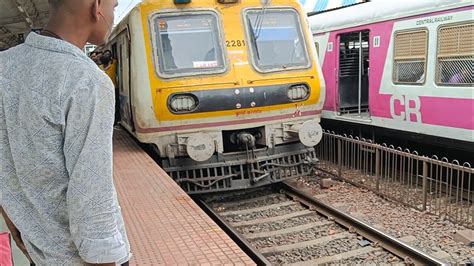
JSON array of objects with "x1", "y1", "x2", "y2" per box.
[{"x1": 198, "y1": 183, "x2": 444, "y2": 265}]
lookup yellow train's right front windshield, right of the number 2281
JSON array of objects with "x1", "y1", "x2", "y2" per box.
[{"x1": 245, "y1": 8, "x2": 310, "y2": 72}]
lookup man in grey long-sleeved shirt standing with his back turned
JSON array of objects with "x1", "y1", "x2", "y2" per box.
[{"x1": 0, "y1": 0, "x2": 130, "y2": 265}]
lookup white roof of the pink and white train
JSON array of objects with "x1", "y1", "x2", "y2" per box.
[{"x1": 309, "y1": 0, "x2": 474, "y2": 33}]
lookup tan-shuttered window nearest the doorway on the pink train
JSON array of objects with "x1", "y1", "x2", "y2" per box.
[{"x1": 392, "y1": 29, "x2": 428, "y2": 85}]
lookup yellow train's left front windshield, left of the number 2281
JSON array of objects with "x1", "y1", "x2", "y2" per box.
[{"x1": 151, "y1": 11, "x2": 226, "y2": 78}]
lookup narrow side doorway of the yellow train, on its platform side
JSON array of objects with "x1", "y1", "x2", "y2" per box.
[{"x1": 118, "y1": 31, "x2": 135, "y2": 131}]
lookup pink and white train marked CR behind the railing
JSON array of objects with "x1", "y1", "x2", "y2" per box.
[{"x1": 309, "y1": 0, "x2": 474, "y2": 151}]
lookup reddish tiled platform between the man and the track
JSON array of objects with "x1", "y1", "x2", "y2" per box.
[{"x1": 114, "y1": 129, "x2": 255, "y2": 265}]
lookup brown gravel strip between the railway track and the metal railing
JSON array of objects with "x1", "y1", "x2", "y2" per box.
[{"x1": 298, "y1": 177, "x2": 474, "y2": 264}]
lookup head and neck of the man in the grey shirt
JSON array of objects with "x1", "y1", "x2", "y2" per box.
[{"x1": 48, "y1": 0, "x2": 118, "y2": 45}]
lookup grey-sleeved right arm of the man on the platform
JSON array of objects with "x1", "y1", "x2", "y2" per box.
[{"x1": 63, "y1": 78, "x2": 129, "y2": 265}]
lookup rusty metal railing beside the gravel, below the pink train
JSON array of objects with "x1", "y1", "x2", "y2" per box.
[{"x1": 316, "y1": 131, "x2": 474, "y2": 229}]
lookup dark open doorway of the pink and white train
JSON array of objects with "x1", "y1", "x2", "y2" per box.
[{"x1": 338, "y1": 30, "x2": 369, "y2": 117}]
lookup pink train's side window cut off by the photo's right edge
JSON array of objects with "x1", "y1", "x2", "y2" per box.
[{"x1": 436, "y1": 21, "x2": 474, "y2": 87}]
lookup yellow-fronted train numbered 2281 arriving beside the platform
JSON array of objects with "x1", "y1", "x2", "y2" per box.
[{"x1": 105, "y1": 0, "x2": 325, "y2": 194}]
